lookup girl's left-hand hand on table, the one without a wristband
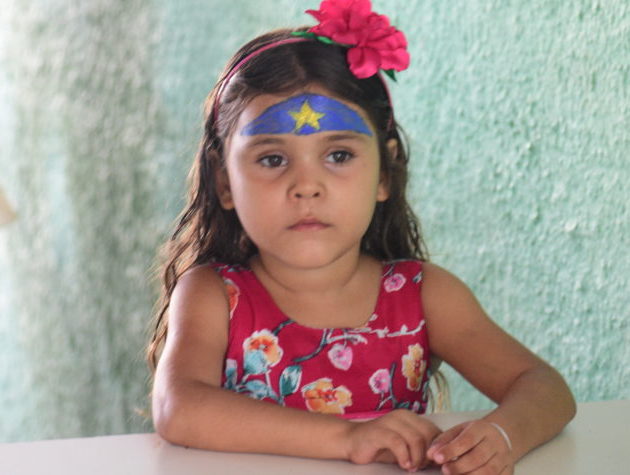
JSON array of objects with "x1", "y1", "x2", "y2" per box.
[{"x1": 348, "y1": 409, "x2": 441, "y2": 471}]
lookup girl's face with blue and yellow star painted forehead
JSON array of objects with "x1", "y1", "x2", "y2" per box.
[{"x1": 217, "y1": 86, "x2": 396, "y2": 269}]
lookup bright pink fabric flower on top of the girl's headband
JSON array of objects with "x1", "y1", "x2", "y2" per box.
[{"x1": 294, "y1": 0, "x2": 409, "y2": 80}]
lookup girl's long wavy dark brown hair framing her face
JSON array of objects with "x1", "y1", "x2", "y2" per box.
[{"x1": 147, "y1": 28, "x2": 427, "y2": 370}]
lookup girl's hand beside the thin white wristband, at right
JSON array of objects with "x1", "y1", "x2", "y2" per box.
[{"x1": 427, "y1": 419, "x2": 514, "y2": 475}]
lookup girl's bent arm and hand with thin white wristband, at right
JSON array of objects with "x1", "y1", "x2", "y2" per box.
[{"x1": 422, "y1": 263, "x2": 576, "y2": 474}]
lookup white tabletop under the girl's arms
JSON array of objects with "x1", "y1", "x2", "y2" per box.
[{"x1": 0, "y1": 401, "x2": 630, "y2": 475}]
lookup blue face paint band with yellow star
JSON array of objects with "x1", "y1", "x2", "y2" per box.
[{"x1": 241, "y1": 94, "x2": 372, "y2": 136}]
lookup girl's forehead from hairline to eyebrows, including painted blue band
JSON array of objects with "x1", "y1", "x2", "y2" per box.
[{"x1": 235, "y1": 90, "x2": 373, "y2": 136}]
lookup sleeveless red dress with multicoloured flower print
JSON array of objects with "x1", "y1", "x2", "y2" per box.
[{"x1": 214, "y1": 261, "x2": 429, "y2": 418}]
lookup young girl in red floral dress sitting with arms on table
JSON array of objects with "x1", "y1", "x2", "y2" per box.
[{"x1": 149, "y1": 0, "x2": 575, "y2": 474}]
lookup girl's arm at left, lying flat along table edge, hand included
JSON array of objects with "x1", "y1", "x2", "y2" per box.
[{"x1": 153, "y1": 267, "x2": 439, "y2": 468}]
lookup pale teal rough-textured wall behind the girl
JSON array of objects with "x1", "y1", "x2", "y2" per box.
[{"x1": 0, "y1": 0, "x2": 630, "y2": 441}]
